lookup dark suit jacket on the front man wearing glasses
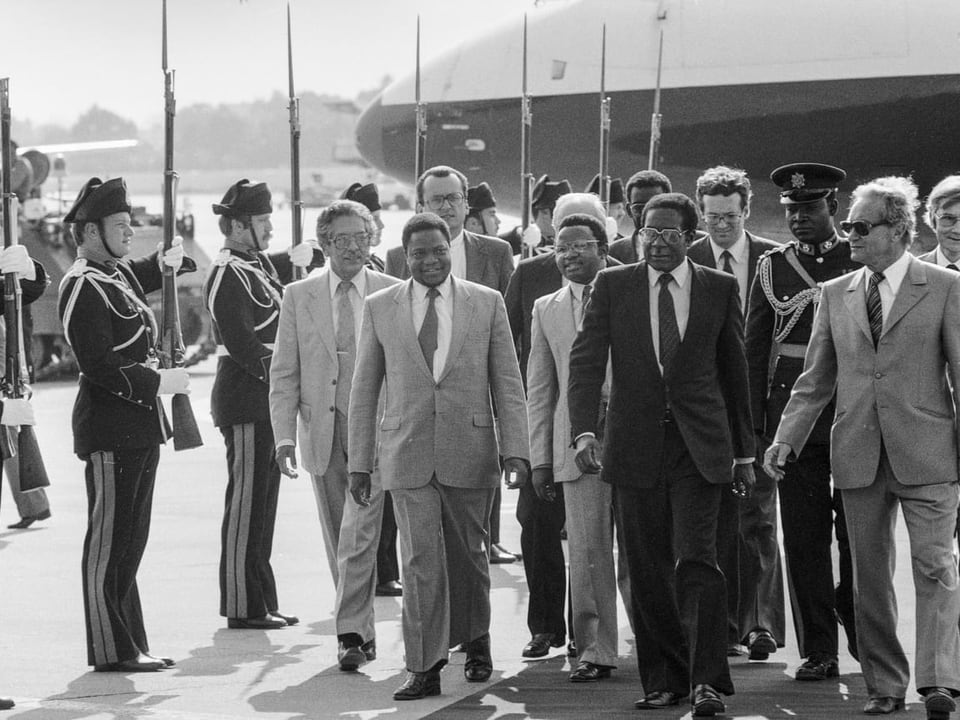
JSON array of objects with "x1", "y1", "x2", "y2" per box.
[{"x1": 568, "y1": 261, "x2": 755, "y2": 488}]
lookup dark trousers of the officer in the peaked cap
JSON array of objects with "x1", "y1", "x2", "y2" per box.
[{"x1": 779, "y1": 445, "x2": 854, "y2": 658}]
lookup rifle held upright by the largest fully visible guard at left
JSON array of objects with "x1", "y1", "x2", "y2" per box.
[{"x1": 160, "y1": 0, "x2": 203, "y2": 450}]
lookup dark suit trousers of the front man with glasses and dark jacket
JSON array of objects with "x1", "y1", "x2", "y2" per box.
[{"x1": 614, "y1": 423, "x2": 733, "y2": 695}]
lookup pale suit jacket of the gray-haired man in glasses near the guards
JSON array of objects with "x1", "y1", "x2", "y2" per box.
[{"x1": 270, "y1": 268, "x2": 399, "y2": 475}]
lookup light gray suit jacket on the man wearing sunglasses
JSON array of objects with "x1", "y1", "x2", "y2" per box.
[{"x1": 774, "y1": 257, "x2": 960, "y2": 489}]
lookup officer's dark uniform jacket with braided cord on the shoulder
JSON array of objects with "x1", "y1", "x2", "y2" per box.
[{"x1": 746, "y1": 235, "x2": 861, "y2": 445}]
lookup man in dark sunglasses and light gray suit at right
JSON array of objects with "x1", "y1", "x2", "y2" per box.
[{"x1": 764, "y1": 177, "x2": 960, "y2": 720}]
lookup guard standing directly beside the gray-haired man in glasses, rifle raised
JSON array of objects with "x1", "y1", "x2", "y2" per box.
[{"x1": 203, "y1": 178, "x2": 314, "y2": 629}]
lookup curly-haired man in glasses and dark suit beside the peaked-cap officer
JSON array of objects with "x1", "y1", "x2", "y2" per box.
[{"x1": 687, "y1": 165, "x2": 785, "y2": 660}]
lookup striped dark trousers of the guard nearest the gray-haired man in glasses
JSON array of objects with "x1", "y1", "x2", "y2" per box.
[{"x1": 220, "y1": 420, "x2": 280, "y2": 618}]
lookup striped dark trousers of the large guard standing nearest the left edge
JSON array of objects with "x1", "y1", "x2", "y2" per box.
[{"x1": 81, "y1": 446, "x2": 160, "y2": 665}]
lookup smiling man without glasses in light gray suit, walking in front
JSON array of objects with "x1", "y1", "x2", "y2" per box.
[{"x1": 348, "y1": 213, "x2": 529, "y2": 700}]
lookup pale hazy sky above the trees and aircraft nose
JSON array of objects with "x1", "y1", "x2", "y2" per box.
[{"x1": 0, "y1": 0, "x2": 533, "y2": 125}]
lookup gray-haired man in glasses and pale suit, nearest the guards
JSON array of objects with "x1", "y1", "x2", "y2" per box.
[{"x1": 270, "y1": 200, "x2": 399, "y2": 671}]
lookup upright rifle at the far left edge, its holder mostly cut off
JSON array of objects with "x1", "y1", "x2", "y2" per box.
[{"x1": 0, "y1": 78, "x2": 50, "y2": 491}]
